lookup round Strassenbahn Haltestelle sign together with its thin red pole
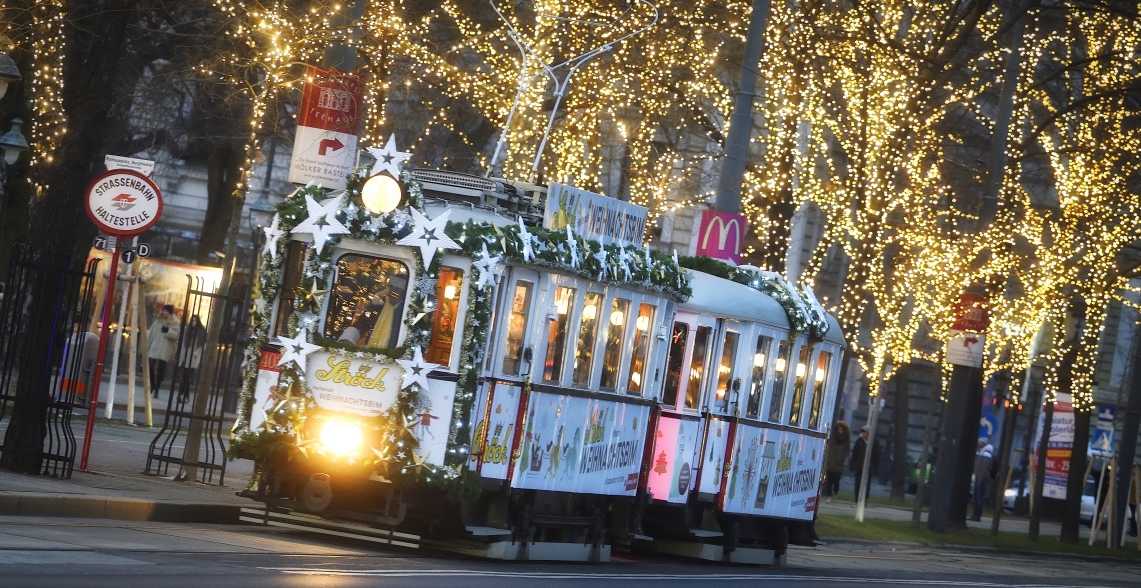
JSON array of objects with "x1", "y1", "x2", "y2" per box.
[{"x1": 79, "y1": 169, "x2": 162, "y2": 472}]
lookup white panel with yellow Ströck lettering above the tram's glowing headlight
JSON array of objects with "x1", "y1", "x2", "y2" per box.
[{"x1": 305, "y1": 352, "x2": 404, "y2": 417}]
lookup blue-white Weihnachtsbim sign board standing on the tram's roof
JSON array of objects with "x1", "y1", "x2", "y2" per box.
[{"x1": 543, "y1": 184, "x2": 646, "y2": 247}]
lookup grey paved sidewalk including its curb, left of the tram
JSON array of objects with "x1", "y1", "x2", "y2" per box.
[{"x1": 0, "y1": 411, "x2": 258, "y2": 523}]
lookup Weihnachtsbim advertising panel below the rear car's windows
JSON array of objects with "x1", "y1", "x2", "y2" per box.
[{"x1": 722, "y1": 424, "x2": 824, "y2": 519}]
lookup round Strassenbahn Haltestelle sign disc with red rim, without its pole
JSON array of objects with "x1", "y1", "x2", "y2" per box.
[{"x1": 86, "y1": 169, "x2": 162, "y2": 236}]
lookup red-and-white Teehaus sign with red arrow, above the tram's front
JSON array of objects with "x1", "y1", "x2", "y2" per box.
[{"x1": 289, "y1": 67, "x2": 364, "y2": 190}]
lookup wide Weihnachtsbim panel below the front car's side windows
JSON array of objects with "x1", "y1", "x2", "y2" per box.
[{"x1": 511, "y1": 392, "x2": 649, "y2": 496}]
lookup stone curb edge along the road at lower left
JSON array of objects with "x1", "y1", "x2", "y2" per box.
[{"x1": 0, "y1": 492, "x2": 242, "y2": 524}]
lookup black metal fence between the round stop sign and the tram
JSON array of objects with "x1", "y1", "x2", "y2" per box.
[{"x1": 146, "y1": 276, "x2": 245, "y2": 485}]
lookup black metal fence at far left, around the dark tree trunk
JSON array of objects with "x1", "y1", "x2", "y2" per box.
[{"x1": 0, "y1": 248, "x2": 99, "y2": 478}]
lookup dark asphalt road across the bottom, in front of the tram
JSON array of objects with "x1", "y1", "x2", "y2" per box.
[{"x1": 0, "y1": 517, "x2": 1141, "y2": 588}]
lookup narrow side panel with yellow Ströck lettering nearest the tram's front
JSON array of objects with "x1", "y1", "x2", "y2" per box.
[{"x1": 469, "y1": 382, "x2": 523, "y2": 480}]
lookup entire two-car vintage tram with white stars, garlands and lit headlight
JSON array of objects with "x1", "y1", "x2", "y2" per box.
[{"x1": 232, "y1": 158, "x2": 844, "y2": 563}]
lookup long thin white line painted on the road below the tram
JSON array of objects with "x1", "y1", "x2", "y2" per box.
[{"x1": 261, "y1": 567, "x2": 1104, "y2": 588}]
